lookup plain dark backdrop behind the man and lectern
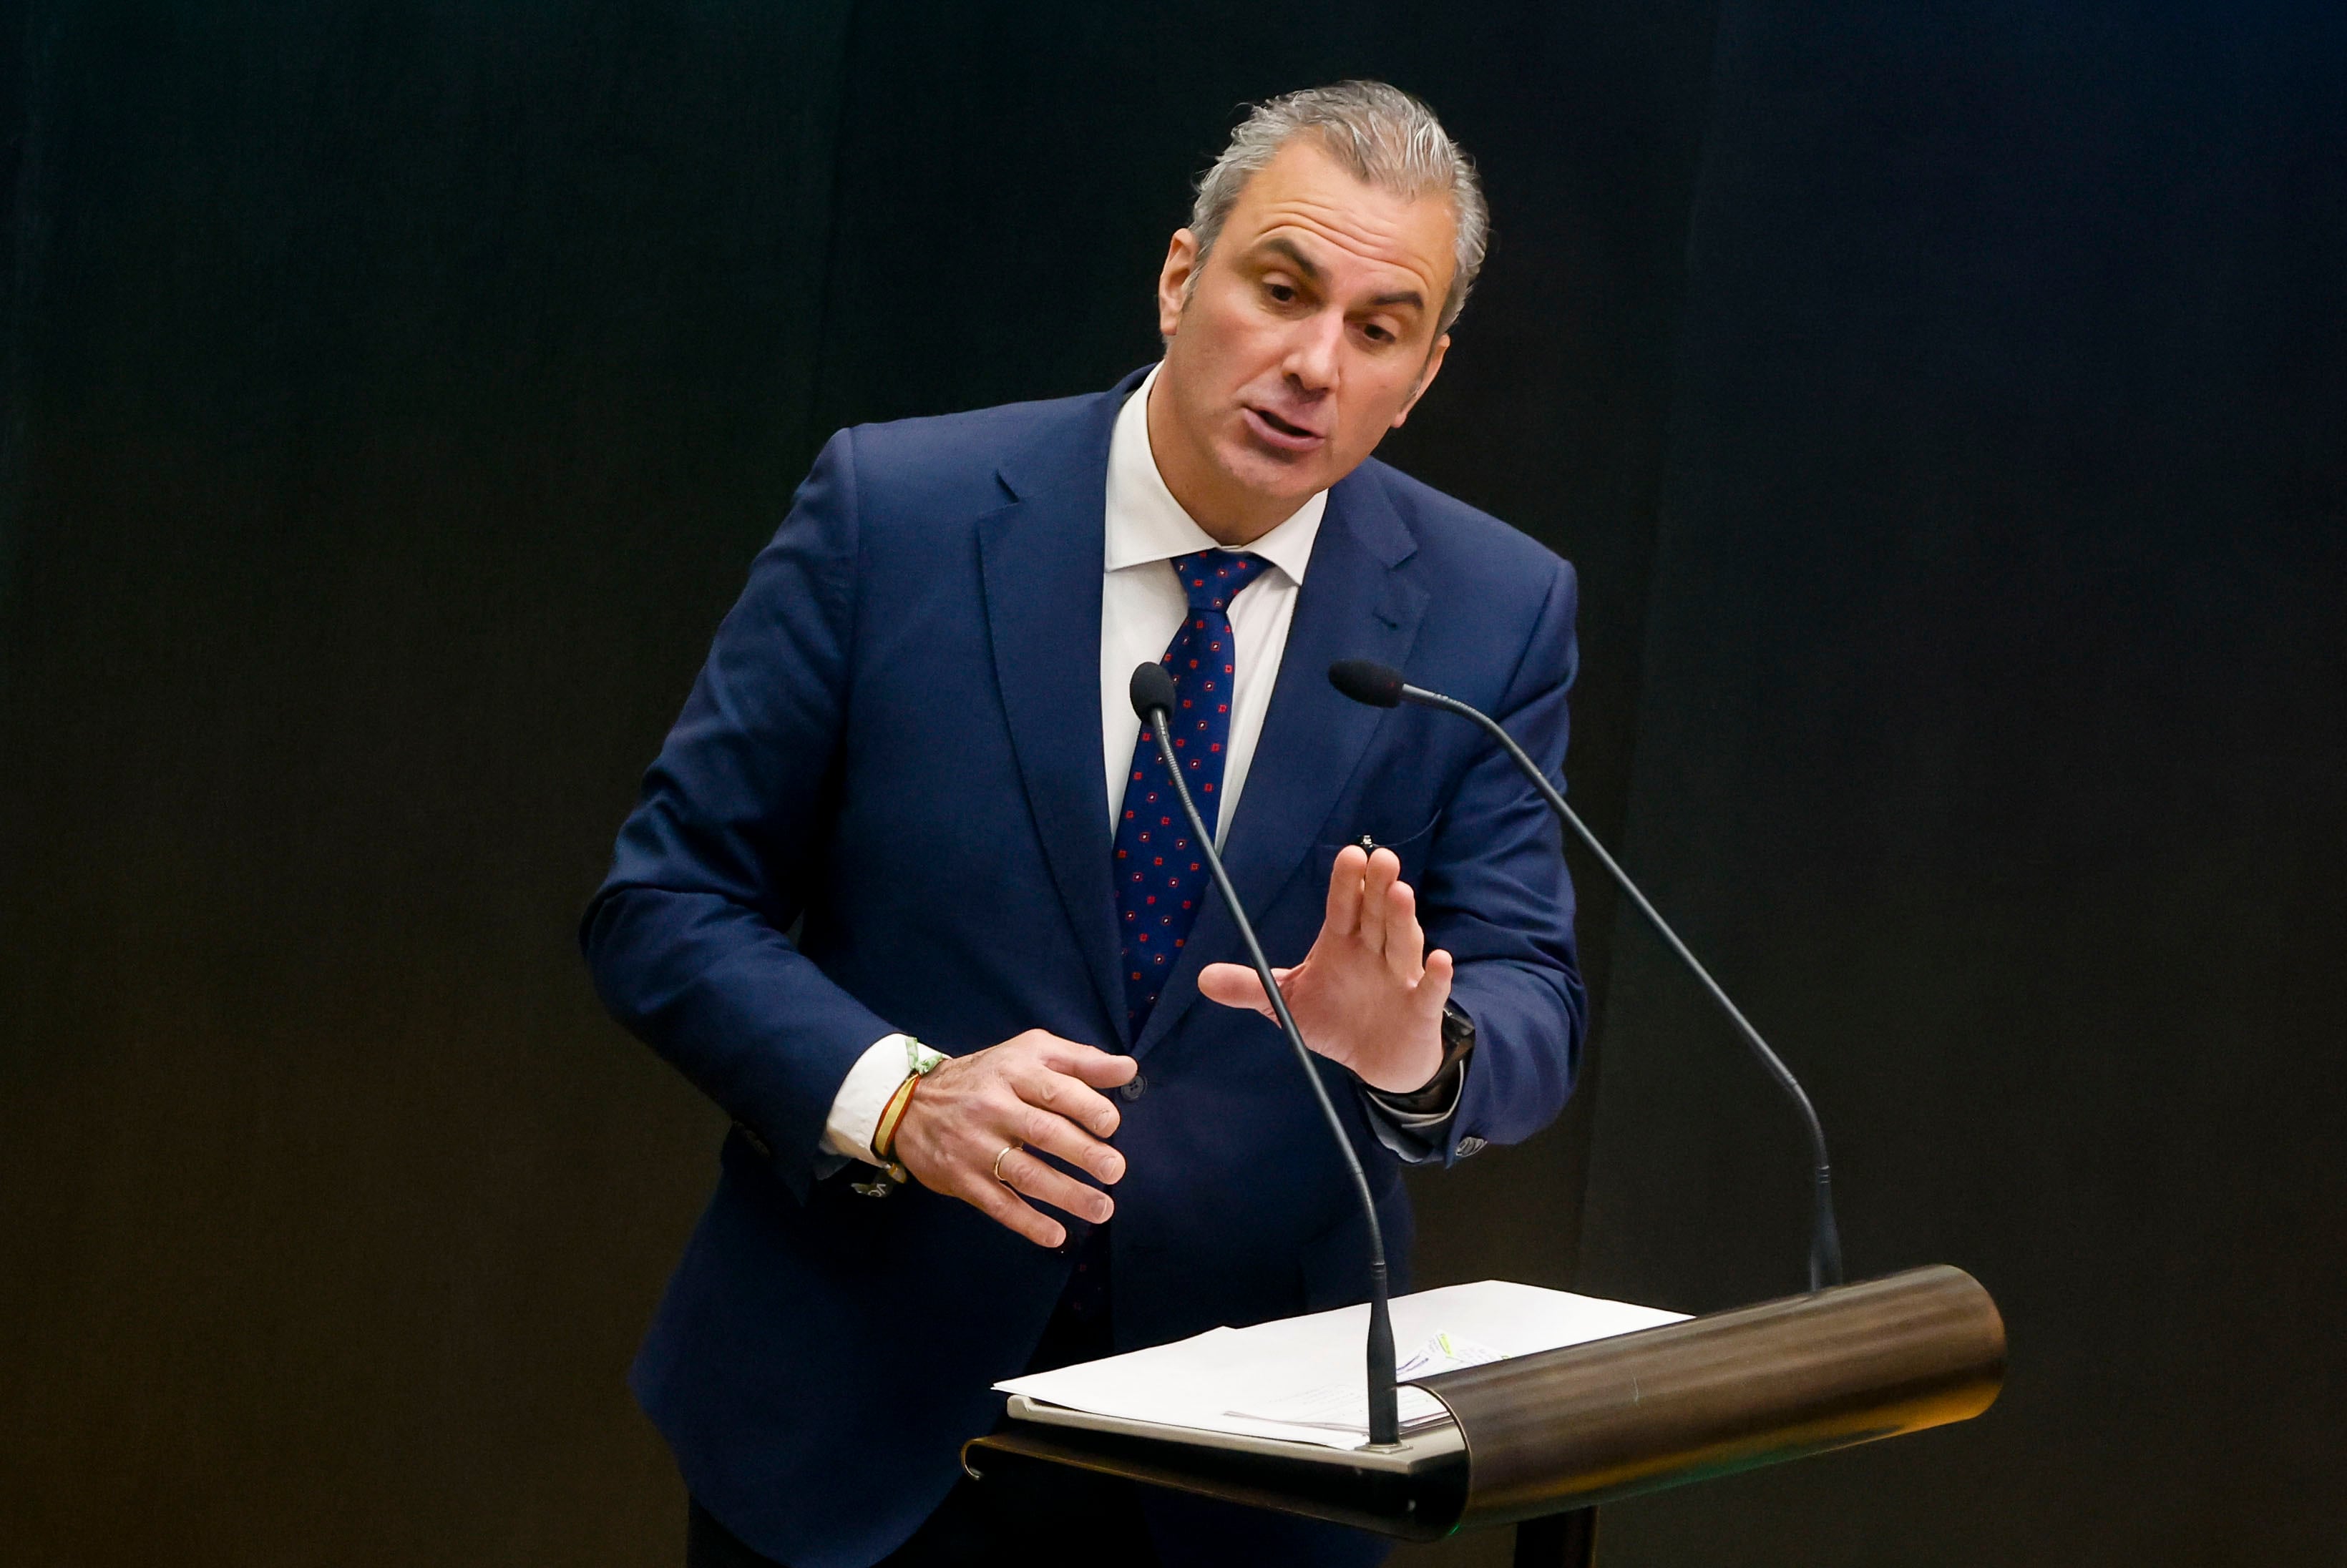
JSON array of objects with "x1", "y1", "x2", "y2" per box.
[{"x1": 0, "y1": 0, "x2": 2347, "y2": 1563}]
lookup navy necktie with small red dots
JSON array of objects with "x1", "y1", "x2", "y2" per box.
[{"x1": 1115, "y1": 549, "x2": 1265, "y2": 1035}]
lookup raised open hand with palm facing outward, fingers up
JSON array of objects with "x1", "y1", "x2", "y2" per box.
[{"x1": 1197, "y1": 845, "x2": 1450, "y2": 1094}]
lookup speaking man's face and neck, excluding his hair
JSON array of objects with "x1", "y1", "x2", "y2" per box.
[{"x1": 1148, "y1": 134, "x2": 1455, "y2": 544}]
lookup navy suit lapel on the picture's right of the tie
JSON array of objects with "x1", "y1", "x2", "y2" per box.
[{"x1": 1110, "y1": 460, "x2": 1427, "y2": 1057}]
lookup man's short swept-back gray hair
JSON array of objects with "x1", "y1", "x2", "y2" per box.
[{"x1": 1190, "y1": 82, "x2": 1490, "y2": 333}]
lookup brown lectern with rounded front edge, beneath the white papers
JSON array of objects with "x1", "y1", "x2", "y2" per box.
[{"x1": 962, "y1": 1265, "x2": 2004, "y2": 1568}]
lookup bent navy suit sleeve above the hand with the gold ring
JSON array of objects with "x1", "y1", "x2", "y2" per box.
[{"x1": 580, "y1": 432, "x2": 892, "y2": 1197}]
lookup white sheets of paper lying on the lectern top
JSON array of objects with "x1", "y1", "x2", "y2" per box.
[{"x1": 995, "y1": 1279, "x2": 1685, "y2": 1449}]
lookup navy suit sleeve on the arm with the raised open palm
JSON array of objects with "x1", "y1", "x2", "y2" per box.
[{"x1": 1418, "y1": 561, "x2": 1589, "y2": 1165}]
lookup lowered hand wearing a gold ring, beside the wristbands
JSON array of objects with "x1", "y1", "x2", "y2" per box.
[{"x1": 892, "y1": 1028, "x2": 1133, "y2": 1246}]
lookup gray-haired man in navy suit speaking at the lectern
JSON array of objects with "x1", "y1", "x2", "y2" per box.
[{"x1": 582, "y1": 82, "x2": 1584, "y2": 1568}]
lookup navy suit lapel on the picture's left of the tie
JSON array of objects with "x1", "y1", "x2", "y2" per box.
[{"x1": 979, "y1": 385, "x2": 1129, "y2": 1042}]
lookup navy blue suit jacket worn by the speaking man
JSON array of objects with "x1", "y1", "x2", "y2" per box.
[{"x1": 582, "y1": 378, "x2": 1584, "y2": 1568}]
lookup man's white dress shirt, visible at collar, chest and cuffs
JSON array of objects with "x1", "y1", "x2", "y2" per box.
[{"x1": 819, "y1": 371, "x2": 1458, "y2": 1174}]
